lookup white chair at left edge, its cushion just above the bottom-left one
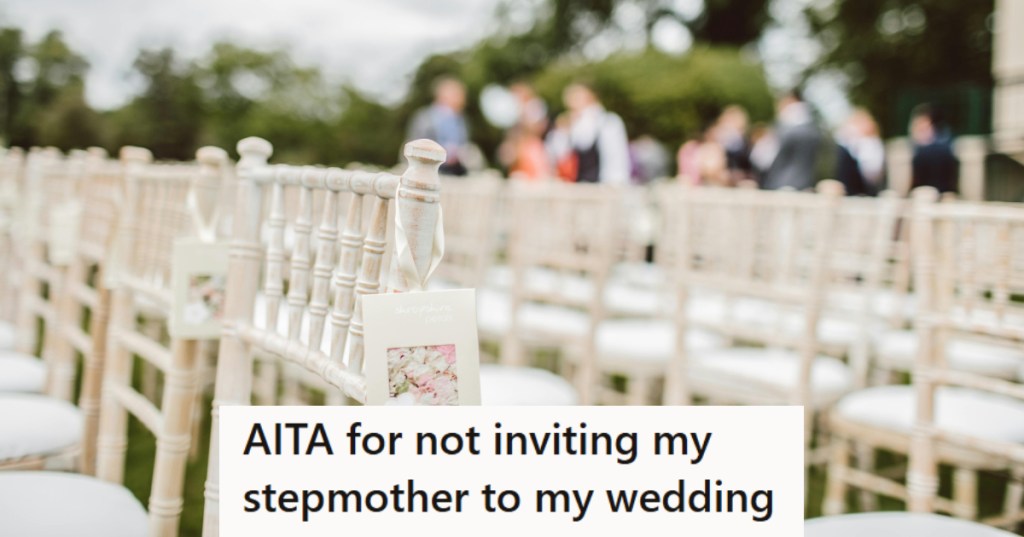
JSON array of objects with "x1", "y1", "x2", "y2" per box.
[{"x1": 0, "y1": 148, "x2": 136, "y2": 473}]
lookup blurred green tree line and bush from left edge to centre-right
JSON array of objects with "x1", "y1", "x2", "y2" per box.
[{"x1": 0, "y1": 0, "x2": 770, "y2": 166}]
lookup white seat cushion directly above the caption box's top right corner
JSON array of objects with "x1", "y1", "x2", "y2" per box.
[{"x1": 689, "y1": 347, "x2": 853, "y2": 405}]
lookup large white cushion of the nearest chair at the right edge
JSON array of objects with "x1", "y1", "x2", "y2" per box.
[{"x1": 835, "y1": 385, "x2": 1024, "y2": 443}]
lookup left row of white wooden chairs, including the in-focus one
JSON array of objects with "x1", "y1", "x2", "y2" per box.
[{"x1": 0, "y1": 138, "x2": 444, "y2": 536}]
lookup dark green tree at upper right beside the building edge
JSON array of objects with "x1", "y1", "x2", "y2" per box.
[{"x1": 807, "y1": 0, "x2": 994, "y2": 135}]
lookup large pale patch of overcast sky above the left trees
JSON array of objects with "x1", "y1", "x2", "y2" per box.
[{"x1": 0, "y1": 0, "x2": 509, "y2": 108}]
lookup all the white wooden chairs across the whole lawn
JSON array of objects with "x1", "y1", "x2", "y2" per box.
[{"x1": 0, "y1": 138, "x2": 1024, "y2": 535}]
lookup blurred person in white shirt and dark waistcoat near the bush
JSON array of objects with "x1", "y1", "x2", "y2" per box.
[{"x1": 549, "y1": 82, "x2": 631, "y2": 184}]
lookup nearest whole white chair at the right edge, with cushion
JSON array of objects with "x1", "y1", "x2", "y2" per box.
[{"x1": 823, "y1": 189, "x2": 1024, "y2": 525}]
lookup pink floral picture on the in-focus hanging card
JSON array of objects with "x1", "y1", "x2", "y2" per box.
[{"x1": 387, "y1": 344, "x2": 459, "y2": 406}]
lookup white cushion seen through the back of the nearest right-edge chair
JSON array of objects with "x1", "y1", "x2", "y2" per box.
[{"x1": 874, "y1": 330, "x2": 1024, "y2": 378}]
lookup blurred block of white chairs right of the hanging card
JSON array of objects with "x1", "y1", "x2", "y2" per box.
[{"x1": 438, "y1": 177, "x2": 1024, "y2": 528}]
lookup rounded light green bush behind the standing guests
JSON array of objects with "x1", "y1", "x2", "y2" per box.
[{"x1": 537, "y1": 47, "x2": 773, "y2": 147}]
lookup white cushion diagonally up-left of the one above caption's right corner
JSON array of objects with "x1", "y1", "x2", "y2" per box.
[{"x1": 596, "y1": 319, "x2": 725, "y2": 367}]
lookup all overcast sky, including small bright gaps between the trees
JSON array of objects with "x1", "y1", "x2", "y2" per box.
[{"x1": 0, "y1": 0, "x2": 849, "y2": 121}]
